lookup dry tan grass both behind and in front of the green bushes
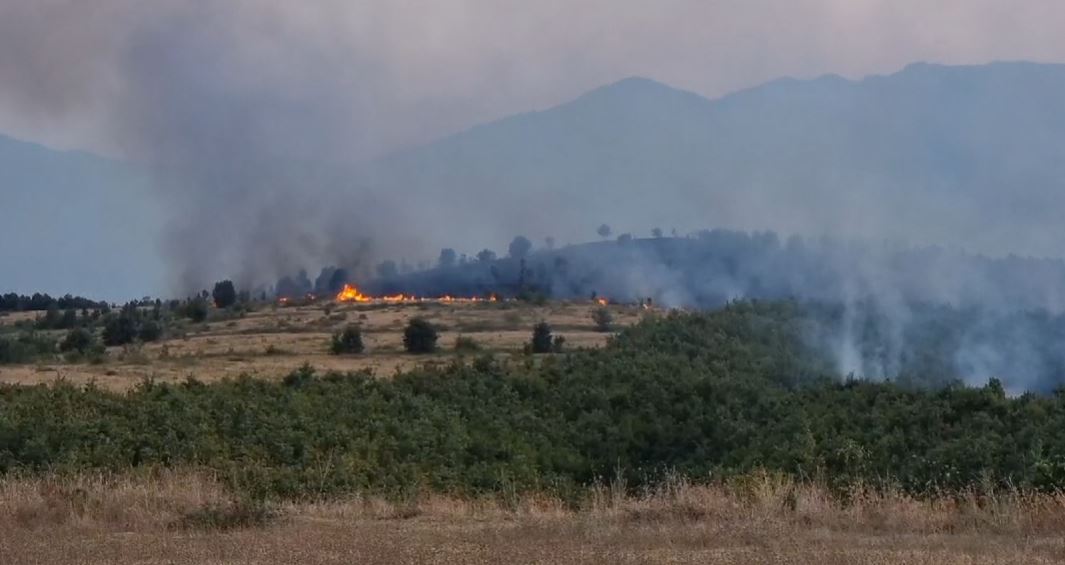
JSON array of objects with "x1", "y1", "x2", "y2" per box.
[{"x1": 0, "y1": 303, "x2": 1065, "y2": 565}]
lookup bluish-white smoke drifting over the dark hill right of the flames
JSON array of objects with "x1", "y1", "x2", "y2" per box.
[{"x1": 377, "y1": 230, "x2": 1065, "y2": 393}]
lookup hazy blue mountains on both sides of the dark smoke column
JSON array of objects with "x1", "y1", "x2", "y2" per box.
[{"x1": 6, "y1": 63, "x2": 1065, "y2": 297}]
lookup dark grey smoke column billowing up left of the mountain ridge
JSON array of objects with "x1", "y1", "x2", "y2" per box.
[{"x1": 0, "y1": 0, "x2": 436, "y2": 293}]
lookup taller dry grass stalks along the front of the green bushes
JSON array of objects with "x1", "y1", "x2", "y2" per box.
[{"x1": 0, "y1": 470, "x2": 1065, "y2": 536}]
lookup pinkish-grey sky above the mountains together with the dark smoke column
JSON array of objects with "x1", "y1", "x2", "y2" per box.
[{"x1": 0, "y1": 0, "x2": 1065, "y2": 294}]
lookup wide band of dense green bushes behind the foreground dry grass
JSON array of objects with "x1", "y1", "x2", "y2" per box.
[{"x1": 6, "y1": 303, "x2": 1065, "y2": 497}]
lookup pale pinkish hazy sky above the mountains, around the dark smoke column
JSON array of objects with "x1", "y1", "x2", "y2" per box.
[{"x1": 0, "y1": 0, "x2": 1065, "y2": 155}]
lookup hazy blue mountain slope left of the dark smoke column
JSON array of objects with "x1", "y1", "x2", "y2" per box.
[{"x1": 0, "y1": 135, "x2": 166, "y2": 300}]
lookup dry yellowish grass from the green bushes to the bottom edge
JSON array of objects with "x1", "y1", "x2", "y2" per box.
[{"x1": 0, "y1": 471, "x2": 1065, "y2": 565}]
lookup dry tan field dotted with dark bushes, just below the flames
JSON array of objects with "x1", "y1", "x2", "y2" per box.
[{"x1": 0, "y1": 302, "x2": 643, "y2": 389}]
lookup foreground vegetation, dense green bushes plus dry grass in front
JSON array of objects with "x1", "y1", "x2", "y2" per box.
[{"x1": 0, "y1": 302, "x2": 1065, "y2": 563}]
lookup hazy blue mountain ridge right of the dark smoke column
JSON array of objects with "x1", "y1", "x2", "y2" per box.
[{"x1": 364, "y1": 63, "x2": 1065, "y2": 256}]
